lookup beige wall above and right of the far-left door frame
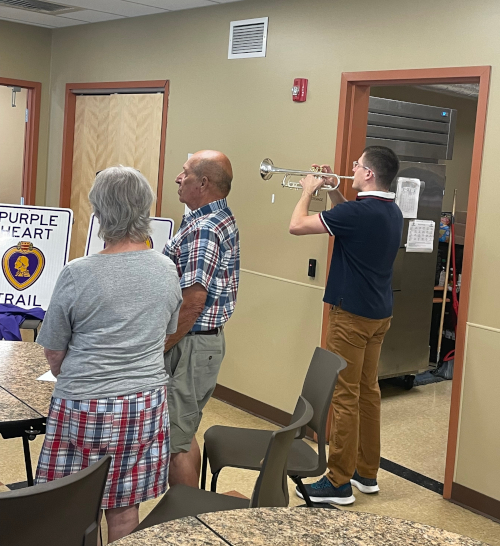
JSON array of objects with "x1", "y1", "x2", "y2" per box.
[{"x1": 0, "y1": 21, "x2": 52, "y2": 205}]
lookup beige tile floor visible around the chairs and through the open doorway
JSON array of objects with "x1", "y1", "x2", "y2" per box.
[{"x1": 0, "y1": 368, "x2": 500, "y2": 546}]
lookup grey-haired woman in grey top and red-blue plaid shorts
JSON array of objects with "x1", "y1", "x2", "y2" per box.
[{"x1": 36, "y1": 166, "x2": 182, "y2": 542}]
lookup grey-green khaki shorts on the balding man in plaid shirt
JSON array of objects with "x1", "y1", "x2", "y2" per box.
[{"x1": 164, "y1": 331, "x2": 226, "y2": 453}]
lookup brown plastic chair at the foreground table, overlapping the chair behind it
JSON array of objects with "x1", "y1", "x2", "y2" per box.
[{"x1": 134, "y1": 397, "x2": 313, "y2": 532}]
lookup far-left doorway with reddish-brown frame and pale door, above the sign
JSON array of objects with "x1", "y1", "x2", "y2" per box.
[{"x1": 0, "y1": 78, "x2": 42, "y2": 205}]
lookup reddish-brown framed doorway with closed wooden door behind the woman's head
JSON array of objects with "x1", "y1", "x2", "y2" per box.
[{"x1": 60, "y1": 81, "x2": 168, "y2": 259}]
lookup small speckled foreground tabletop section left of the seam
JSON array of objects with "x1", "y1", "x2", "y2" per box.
[{"x1": 112, "y1": 517, "x2": 225, "y2": 546}]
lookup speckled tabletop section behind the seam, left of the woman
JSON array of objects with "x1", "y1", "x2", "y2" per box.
[{"x1": 0, "y1": 341, "x2": 54, "y2": 416}]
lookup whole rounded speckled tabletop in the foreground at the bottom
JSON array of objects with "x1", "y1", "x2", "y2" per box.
[{"x1": 113, "y1": 508, "x2": 486, "y2": 546}]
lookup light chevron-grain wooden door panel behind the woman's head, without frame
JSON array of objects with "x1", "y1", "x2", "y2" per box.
[{"x1": 70, "y1": 93, "x2": 163, "y2": 260}]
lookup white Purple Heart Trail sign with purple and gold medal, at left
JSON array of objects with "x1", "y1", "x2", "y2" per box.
[{"x1": 0, "y1": 204, "x2": 73, "y2": 310}]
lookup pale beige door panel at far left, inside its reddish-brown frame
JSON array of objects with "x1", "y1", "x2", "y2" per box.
[{"x1": 0, "y1": 85, "x2": 28, "y2": 204}]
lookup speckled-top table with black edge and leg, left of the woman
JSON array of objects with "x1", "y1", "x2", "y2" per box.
[{"x1": 0, "y1": 341, "x2": 54, "y2": 485}]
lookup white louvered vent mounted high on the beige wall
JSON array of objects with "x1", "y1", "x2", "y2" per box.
[{"x1": 227, "y1": 17, "x2": 269, "y2": 59}]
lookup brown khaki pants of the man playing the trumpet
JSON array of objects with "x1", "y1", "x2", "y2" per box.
[{"x1": 326, "y1": 307, "x2": 391, "y2": 487}]
